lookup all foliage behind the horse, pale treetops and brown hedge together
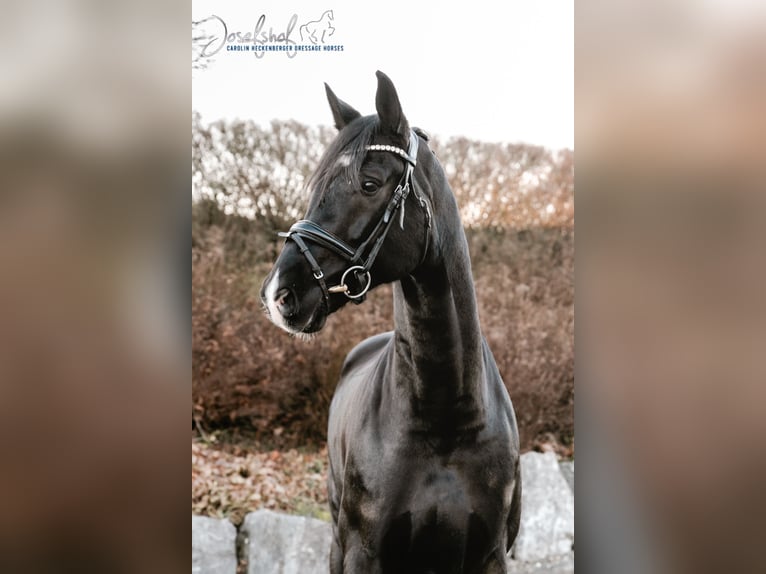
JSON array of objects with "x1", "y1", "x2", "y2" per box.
[{"x1": 192, "y1": 116, "x2": 574, "y2": 455}]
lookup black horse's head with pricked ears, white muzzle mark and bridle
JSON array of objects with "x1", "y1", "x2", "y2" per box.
[{"x1": 261, "y1": 72, "x2": 430, "y2": 334}]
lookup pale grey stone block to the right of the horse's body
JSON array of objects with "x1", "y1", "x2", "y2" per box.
[{"x1": 513, "y1": 452, "x2": 574, "y2": 562}]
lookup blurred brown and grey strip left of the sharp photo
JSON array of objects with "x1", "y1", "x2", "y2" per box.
[{"x1": 0, "y1": 0, "x2": 190, "y2": 573}]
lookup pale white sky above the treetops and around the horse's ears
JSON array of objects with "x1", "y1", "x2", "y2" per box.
[{"x1": 192, "y1": 0, "x2": 574, "y2": 149}]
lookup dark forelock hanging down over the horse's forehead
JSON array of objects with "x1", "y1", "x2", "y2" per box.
[{"x1": 308, "y1": 115, "x2": 378, "y2": 202}]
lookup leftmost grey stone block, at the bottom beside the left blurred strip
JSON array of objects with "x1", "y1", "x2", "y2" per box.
[{"x1": 192, "y1": 516, "x2": 237, "y2": 574}]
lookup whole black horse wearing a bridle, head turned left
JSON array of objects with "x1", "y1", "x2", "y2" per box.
[{"x1": 261, "y1": 72, "x2": 521, "y2": 574}]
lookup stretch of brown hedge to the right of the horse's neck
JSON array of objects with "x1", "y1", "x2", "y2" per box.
[{"x1": 468, "y1": 228, "x2": 574, "y2": 452}]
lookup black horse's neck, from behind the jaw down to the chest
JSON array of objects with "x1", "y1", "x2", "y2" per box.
[{"x1": 394, "y1": 168, "x2": 484, "y2": 426}]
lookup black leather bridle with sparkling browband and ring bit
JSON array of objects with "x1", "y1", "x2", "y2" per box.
[{"x1": 278, "y1": 131, "x2": 431, "y2": 309}]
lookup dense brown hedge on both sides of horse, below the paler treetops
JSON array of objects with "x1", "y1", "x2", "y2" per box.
[{"x1": 192, "y1": 202, "x2": 574, "y2": 451}]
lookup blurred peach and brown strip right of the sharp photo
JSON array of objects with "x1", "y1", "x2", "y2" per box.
[{"x1": 576, "y1": 1, "x2": 766, "y2": 574}]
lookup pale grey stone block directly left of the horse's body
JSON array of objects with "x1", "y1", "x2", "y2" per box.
[{"x1": 240, "y1": 510, "x2": 332, "y2": 574}]
